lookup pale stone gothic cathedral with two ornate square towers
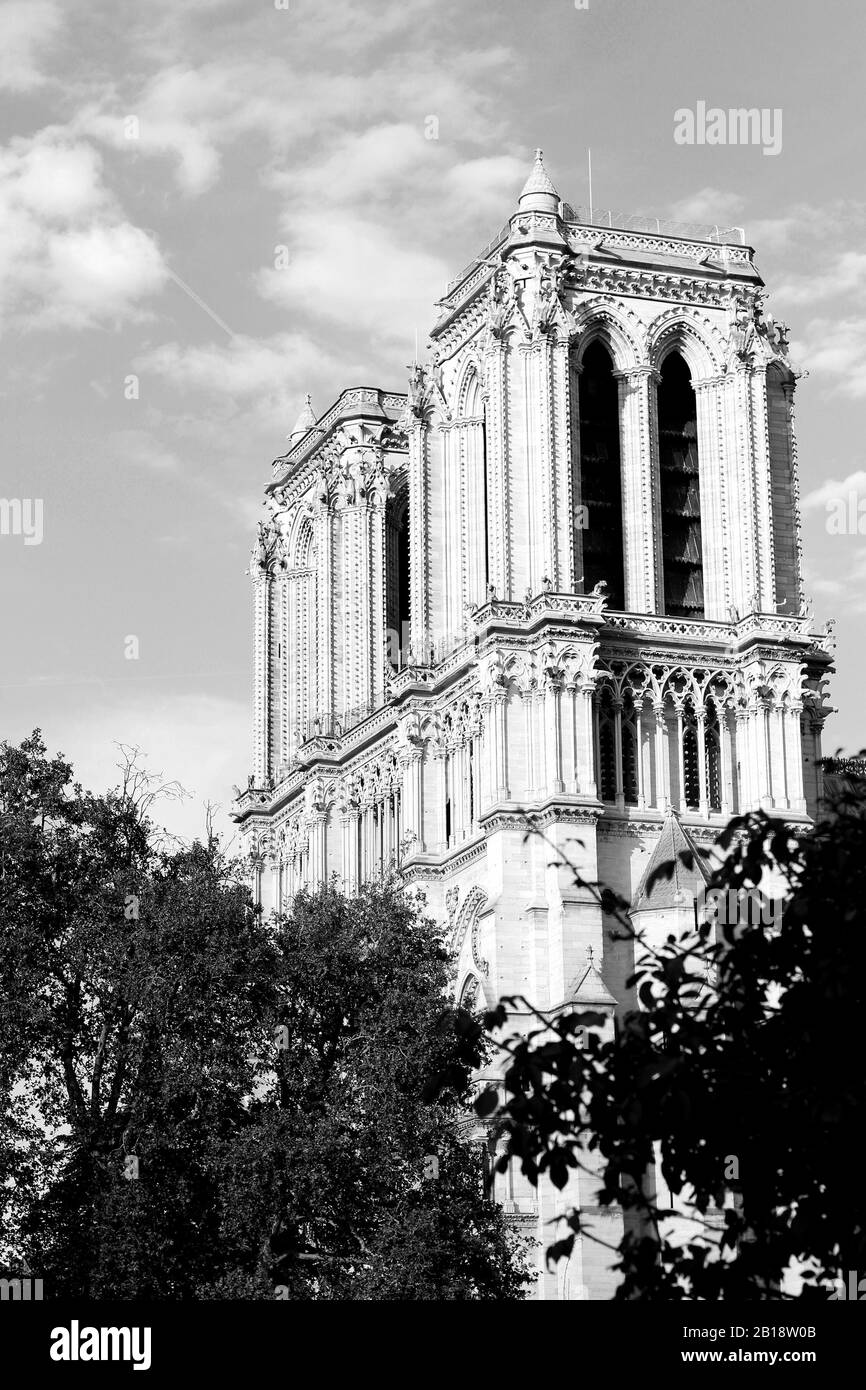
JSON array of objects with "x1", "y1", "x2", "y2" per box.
[{"x1": 235, "y1": 153, "x2": 831, "y2": 1298}]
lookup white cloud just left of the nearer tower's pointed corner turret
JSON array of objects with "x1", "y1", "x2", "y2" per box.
[{"x1": 257, "y1": 122, "x2": 527, "y2": 350}]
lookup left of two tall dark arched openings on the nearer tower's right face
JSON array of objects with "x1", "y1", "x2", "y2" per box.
[{"x1": 575, "y1": 342, "x2": 626, "y2": 609}]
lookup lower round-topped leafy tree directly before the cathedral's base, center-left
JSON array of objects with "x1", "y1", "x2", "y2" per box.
[{"x1": 207, "y1": 883, "x2": 525, "y2": 1300}]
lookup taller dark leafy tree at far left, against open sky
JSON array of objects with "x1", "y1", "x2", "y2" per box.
[{"x1": 0, "y1": 733, "x2": 278, "y2": 1298}]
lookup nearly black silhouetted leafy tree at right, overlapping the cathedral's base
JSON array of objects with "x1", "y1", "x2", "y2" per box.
[{"x1": 467, "y1": 780, "x2": 866, "y2": 1300}]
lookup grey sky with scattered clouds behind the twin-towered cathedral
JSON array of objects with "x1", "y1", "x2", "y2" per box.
[{"x1": 0, "y1": 0, "x2": 866, "y2": 837}]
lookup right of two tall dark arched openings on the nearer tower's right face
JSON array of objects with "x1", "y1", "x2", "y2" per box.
[{"x1": 659, "y1": 352, "x2": 703, "y2": 617}]
